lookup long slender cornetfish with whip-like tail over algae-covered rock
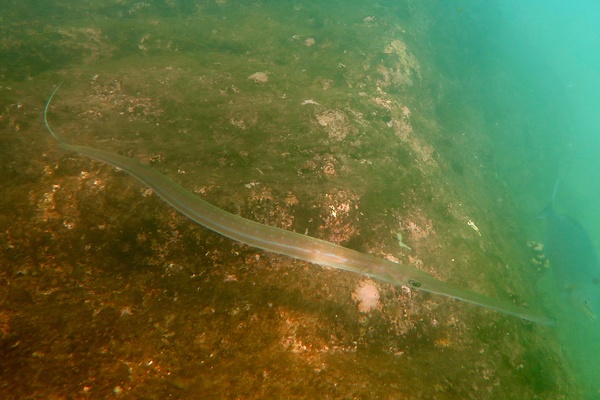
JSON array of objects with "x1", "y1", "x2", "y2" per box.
[{"x1": 43, "y1": 82, "x2": 554, "y2": 325}]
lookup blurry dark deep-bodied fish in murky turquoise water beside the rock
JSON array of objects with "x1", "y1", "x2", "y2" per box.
[{"x1": 543, "y1": 205, "x2": 600, "y2": 319}]
